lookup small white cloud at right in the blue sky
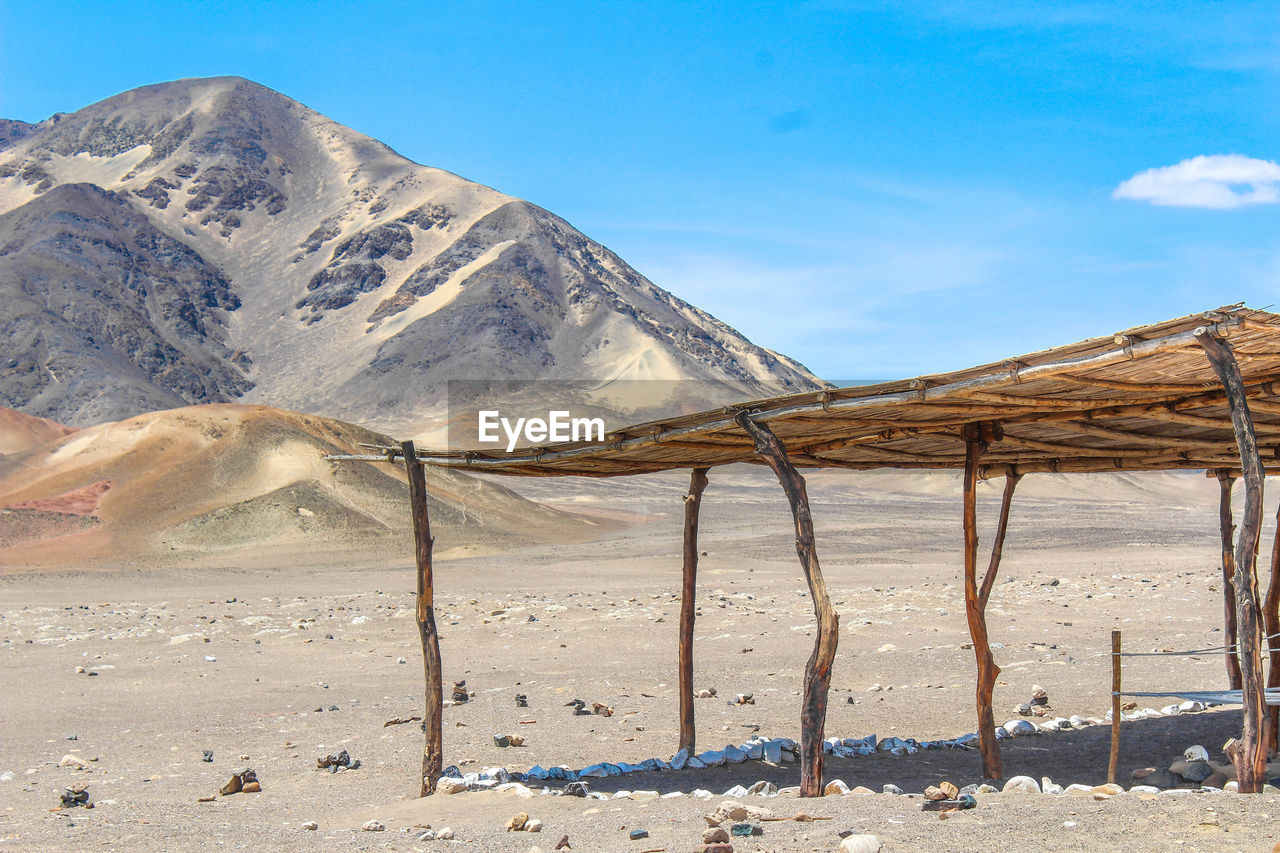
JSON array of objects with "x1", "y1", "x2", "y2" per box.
[{"x1": 1111, "y1": 154, "x2": 1280, "y2": 210}]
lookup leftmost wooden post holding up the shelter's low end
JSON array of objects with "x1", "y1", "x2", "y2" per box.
[{"x1": 401, "y1": 442, "x2": 444, "y2": 797}]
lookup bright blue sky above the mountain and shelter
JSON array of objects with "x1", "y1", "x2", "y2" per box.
[{"x1": 0, "y1": 0, "x2": 1280, "y2": 378}]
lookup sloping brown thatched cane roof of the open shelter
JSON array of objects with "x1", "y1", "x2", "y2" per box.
[{"x1": 343, "y1": 306, "x2": 1280, "y2": 476}]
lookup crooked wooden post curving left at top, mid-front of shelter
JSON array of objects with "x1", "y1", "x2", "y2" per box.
[{"x1": 736, "y1": 411, "x2": 840, "y2": 797}]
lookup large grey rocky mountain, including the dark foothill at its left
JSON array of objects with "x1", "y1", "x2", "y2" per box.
[{"x1": 0, "y1": 77, "x2": 820, "y2": 434}]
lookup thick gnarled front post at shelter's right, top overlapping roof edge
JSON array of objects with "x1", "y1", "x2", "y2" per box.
[{"x1": 1196, "y1": 329, "x2": 1267, "y2": 794}]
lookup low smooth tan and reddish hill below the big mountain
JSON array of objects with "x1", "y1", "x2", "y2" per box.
[{"x1": 0, "y1": 405, "x2": 611, "y2": 567}]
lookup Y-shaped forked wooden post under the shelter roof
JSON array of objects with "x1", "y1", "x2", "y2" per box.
[{"x1": 963, "y1": 423, "x2": 1020, "y2": 779}]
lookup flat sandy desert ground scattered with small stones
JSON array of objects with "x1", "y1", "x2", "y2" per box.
[{"x1": 0, "y1": 469, "x2": 1280, "y2": 853}]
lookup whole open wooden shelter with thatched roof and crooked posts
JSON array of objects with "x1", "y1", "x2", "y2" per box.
[{"x1": 330, "y1": 305, "x2": 1280, "y2": 797}]
